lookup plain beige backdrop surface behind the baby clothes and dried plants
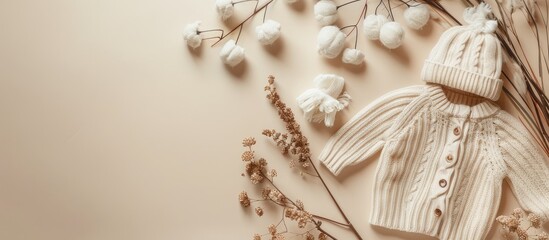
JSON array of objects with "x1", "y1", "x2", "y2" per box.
[{"x1": 0, "y1": 0, "x2": 544, "y2": 240}]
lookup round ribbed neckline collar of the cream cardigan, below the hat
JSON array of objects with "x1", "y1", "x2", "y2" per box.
[{"x1": 428, "y1": 84, "x2": 500, "y2": 118}]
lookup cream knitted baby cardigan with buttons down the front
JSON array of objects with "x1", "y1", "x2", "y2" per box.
[{"x1": 320, "y1": 85, "x2": 549, "y2": 240}]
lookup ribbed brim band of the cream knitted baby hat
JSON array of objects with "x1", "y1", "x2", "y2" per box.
[{"x1": 421, "y1": 61, "x2": 503, "y2": 101}]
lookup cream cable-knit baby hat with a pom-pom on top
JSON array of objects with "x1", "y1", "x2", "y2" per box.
[{"x1": 421, "y1": 3, "x2": 503, "y2": 101}]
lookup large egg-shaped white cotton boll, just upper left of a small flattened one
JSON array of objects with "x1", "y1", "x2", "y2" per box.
[{"x1": 317, "y1": 26, "x2": 346, "y2": 58}]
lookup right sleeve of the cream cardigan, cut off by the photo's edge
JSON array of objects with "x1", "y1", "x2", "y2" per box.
[{"x1": 497, "y1": 113, "x2": 549, "y2": 220}]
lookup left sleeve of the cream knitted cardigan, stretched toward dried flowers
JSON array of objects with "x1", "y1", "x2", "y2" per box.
[{"x1": 319, "y1": 85, "x2": 425, "y2": 175}]
